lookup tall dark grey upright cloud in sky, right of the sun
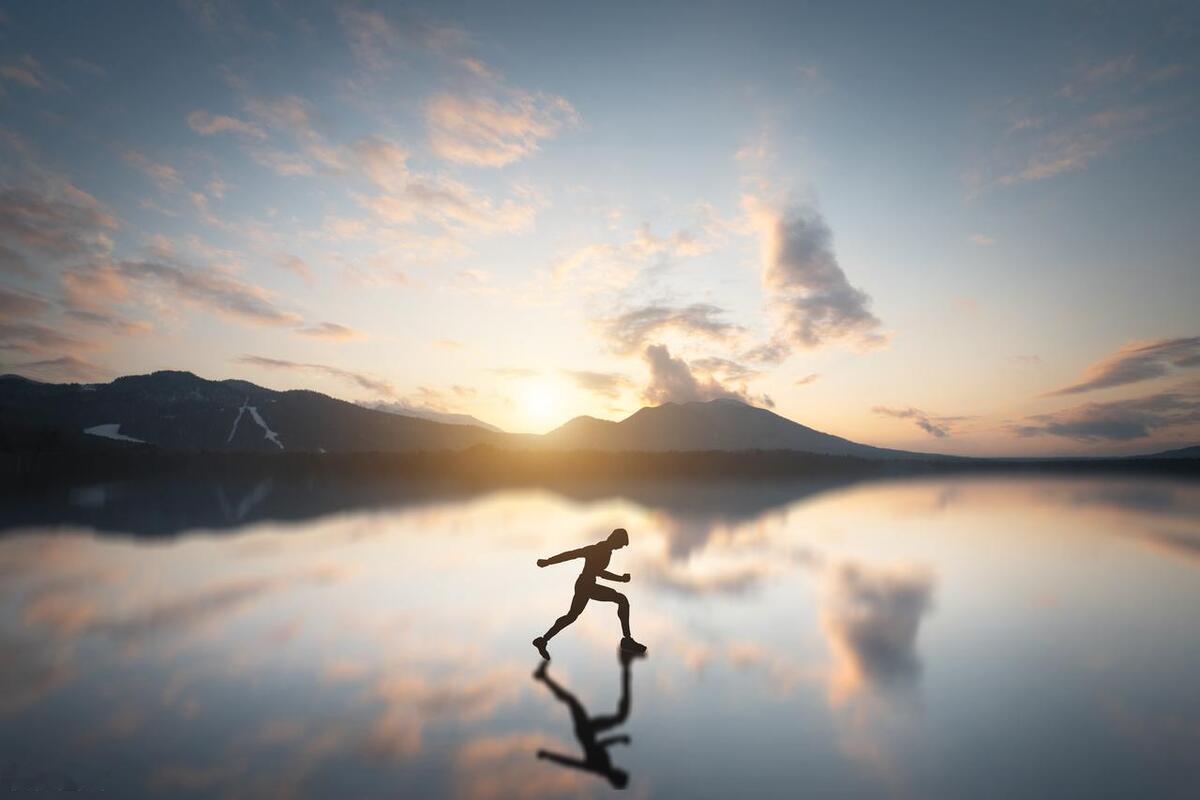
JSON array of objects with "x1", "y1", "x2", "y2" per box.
[{"x1": 744, "y1": 197, "x2": 886, "y2": 349}]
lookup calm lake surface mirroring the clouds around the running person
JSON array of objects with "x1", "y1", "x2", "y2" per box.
[{"x1": 0, "y1": 476, "x2": 1200, "y2": 800}]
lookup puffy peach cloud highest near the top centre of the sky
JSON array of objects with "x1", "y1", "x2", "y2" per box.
[{"x1": 425, "y1": 90, "x2": 578, "y2": 167}]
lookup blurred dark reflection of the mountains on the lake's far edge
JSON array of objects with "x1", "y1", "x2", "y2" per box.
[{"x1": 0, "y1": 471, "x2": 854, "y2": 537}]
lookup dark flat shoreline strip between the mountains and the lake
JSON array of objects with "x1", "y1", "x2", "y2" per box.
[{"x1": 0, "y1": 446, "x2": 1200, "y2": 491}]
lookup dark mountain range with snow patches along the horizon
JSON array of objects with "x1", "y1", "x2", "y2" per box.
[{"x1": 0, "y1": 371, "x2": 1196, "y2": 459}]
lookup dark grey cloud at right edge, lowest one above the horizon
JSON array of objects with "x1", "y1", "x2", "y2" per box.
[{"x1": 1009, "y1": 390, "x2": 1200, "y2": 441}]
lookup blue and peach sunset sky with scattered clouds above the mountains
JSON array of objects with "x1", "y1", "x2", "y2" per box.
[{"x1": 0, "y1": 0, "x2": 1200, "y2": 456}]
